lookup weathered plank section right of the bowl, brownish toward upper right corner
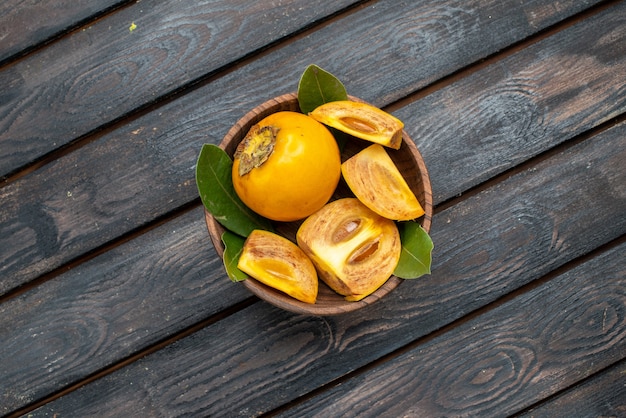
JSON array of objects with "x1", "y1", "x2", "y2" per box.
[{"x1": 396, "y1": 3, "x2": 626, "y2": 201}]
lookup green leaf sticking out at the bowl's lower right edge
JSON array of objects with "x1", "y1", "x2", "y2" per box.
[{"x1": 393, "y1": 222, "x2": 434, "y2": 279}]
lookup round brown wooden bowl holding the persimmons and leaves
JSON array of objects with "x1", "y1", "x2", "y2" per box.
[{"x1": 205, "y1": 93, "x2": 433, "y2": 316}]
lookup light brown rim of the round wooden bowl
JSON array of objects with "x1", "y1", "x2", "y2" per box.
[{"x1": 204, "y1": 92, "x2": 433, "y2": 316}]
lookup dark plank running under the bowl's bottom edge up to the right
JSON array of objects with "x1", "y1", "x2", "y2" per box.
[{"x1": 22, "y1": 119, "x2": 626, "y2": 416}]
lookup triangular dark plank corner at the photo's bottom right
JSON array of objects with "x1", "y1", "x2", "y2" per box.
[{"x1": 516, "y1": 360, "x2": 626, "y2": 418}]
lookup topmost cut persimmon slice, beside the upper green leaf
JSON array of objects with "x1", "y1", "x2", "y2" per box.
[{"x1": 309, "y1": 100, "x2": 404, "y2": 149}]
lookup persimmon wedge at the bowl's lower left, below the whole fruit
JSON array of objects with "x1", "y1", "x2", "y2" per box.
[{"x1": 237, "y1": 230, "x2": 318, "y2": 303}]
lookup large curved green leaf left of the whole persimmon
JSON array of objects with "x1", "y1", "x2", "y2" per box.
[{"x1": 196, "y1": 144, "x2": 273, "y2": 237}]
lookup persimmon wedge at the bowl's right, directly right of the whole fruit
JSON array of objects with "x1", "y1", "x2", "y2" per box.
[{"x1": 341, "y1": 144, "x2": 424, "y2": 221}]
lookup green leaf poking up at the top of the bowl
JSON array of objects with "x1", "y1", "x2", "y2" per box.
[{"x1": 298, "y1": 64, "x2": 348, "y2": 115}]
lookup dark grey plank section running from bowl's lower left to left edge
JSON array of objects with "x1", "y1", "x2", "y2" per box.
[{"x1": 0, "y1": 208, "x2": 250, "y2": 415}]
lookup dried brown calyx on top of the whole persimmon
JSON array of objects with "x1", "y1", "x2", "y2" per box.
[{"x1": 234, "y1": 124, "x2": 280, "y2": 176}]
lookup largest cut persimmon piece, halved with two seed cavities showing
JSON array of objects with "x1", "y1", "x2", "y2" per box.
[{"x1": 296, "y1": 198, "x2": 402, "y2": 301}]
